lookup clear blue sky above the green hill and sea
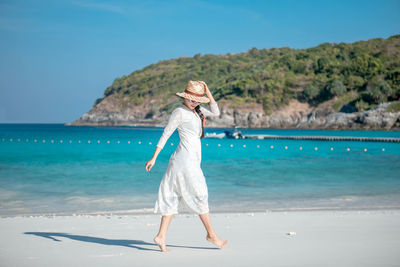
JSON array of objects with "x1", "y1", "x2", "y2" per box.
[{"x1": 0, "y1": 0, "x2": 400, "y2": 123}]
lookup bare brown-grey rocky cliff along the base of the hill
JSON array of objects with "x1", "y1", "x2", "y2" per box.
[{"x1": 66, "y1": 96, "x2": 400, "y2": 130}]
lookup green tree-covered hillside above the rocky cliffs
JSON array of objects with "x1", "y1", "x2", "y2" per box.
[{"x1": 94, "y1": 35, "x2": 400, "y2": 114}]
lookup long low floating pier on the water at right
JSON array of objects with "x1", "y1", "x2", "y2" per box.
[{"x1": 243, "y1": 134, "x2": 400, "y2": 143}]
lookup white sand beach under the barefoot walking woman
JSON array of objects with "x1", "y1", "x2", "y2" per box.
[{"x1": 0, "y1": 210, "x2": 400, "y2": 267}]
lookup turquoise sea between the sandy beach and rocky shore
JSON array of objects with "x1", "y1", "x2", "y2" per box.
[{"x1": 0, "y1": 124, "x2": 400, "y2": 216}]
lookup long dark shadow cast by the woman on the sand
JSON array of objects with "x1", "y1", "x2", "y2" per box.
[{"x1": 24, "y1": 232, "x2": 219, "y2": 252}]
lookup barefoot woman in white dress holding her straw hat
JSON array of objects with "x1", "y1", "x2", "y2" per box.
[{"x1": 145, "y1": 81, "x2": 228, "y2": 252}]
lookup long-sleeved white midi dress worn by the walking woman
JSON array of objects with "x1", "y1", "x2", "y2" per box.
[{"x1": 154, "y1": 103, "x2": 220, "y2": 215}]
